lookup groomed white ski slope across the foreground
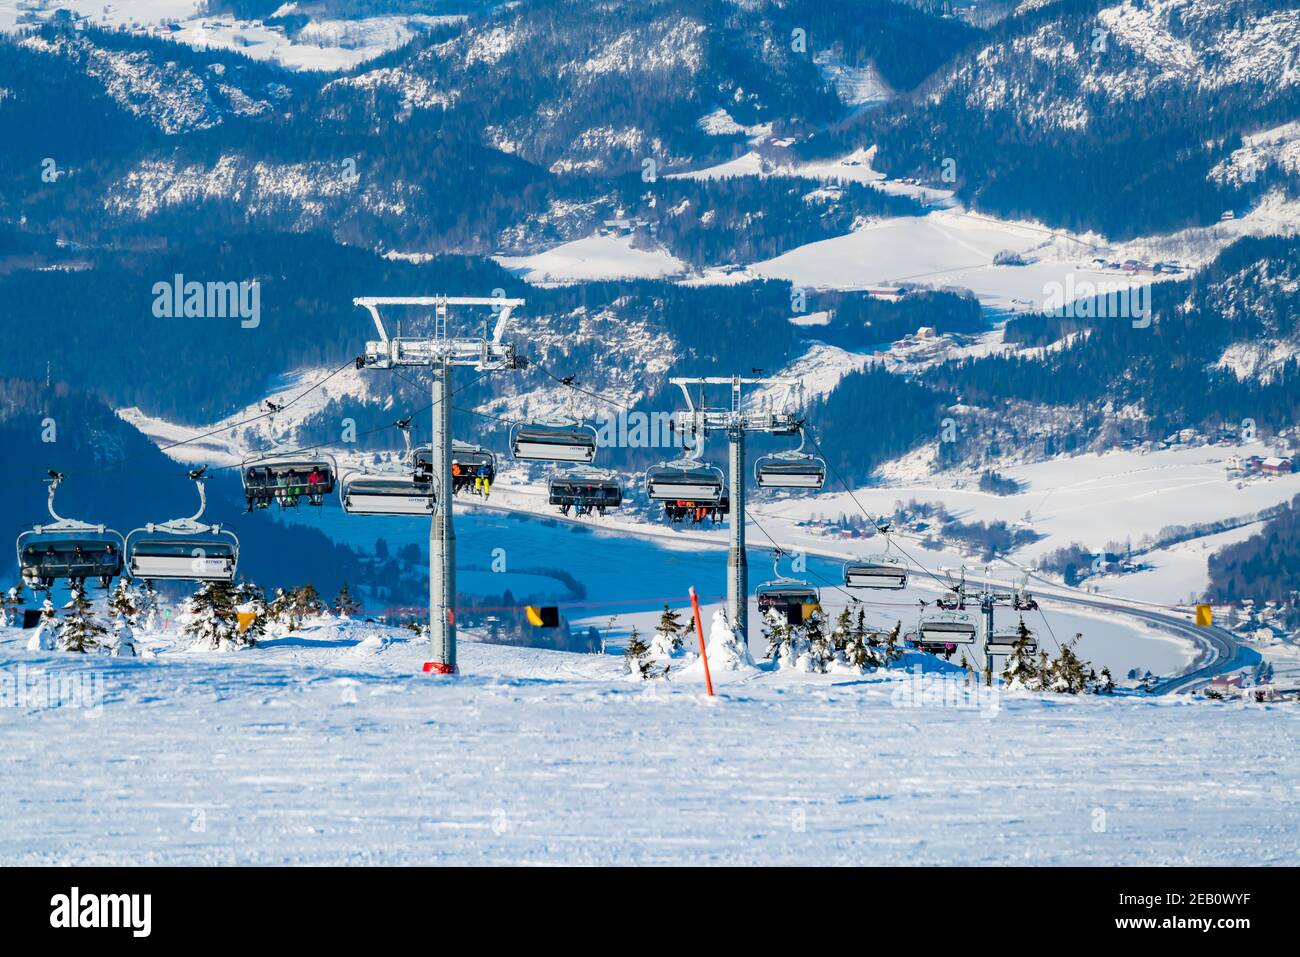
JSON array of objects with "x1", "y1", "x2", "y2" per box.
[{"x1": 0, "y1": 622, "x2": 1300, "y2": 866}]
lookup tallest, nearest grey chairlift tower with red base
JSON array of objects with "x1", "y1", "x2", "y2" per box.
[{"x1": 352, "y1": 295, "x2": 528, "y2": 675}]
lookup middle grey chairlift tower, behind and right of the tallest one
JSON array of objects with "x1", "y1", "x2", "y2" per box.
[{"x1": 668, "y1": 376, "x2": 801, "y2": 642}]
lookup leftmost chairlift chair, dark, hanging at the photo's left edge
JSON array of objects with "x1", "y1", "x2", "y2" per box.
[{"x1": 16, "y1": 469, "x2": 126, "y2": 592}]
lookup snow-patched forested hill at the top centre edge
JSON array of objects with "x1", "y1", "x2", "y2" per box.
[{"x1": 327, "y1": 0, "x2": 970, "y2": 174}]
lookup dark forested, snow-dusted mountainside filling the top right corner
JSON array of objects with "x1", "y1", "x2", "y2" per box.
[{"x1": 837, "y1": 0, "x2": 1300, "y2": 237}]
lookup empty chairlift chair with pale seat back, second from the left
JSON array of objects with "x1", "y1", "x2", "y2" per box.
[{"x1": 126, "y1": 467, "x2": 239, "y2": 581}]
